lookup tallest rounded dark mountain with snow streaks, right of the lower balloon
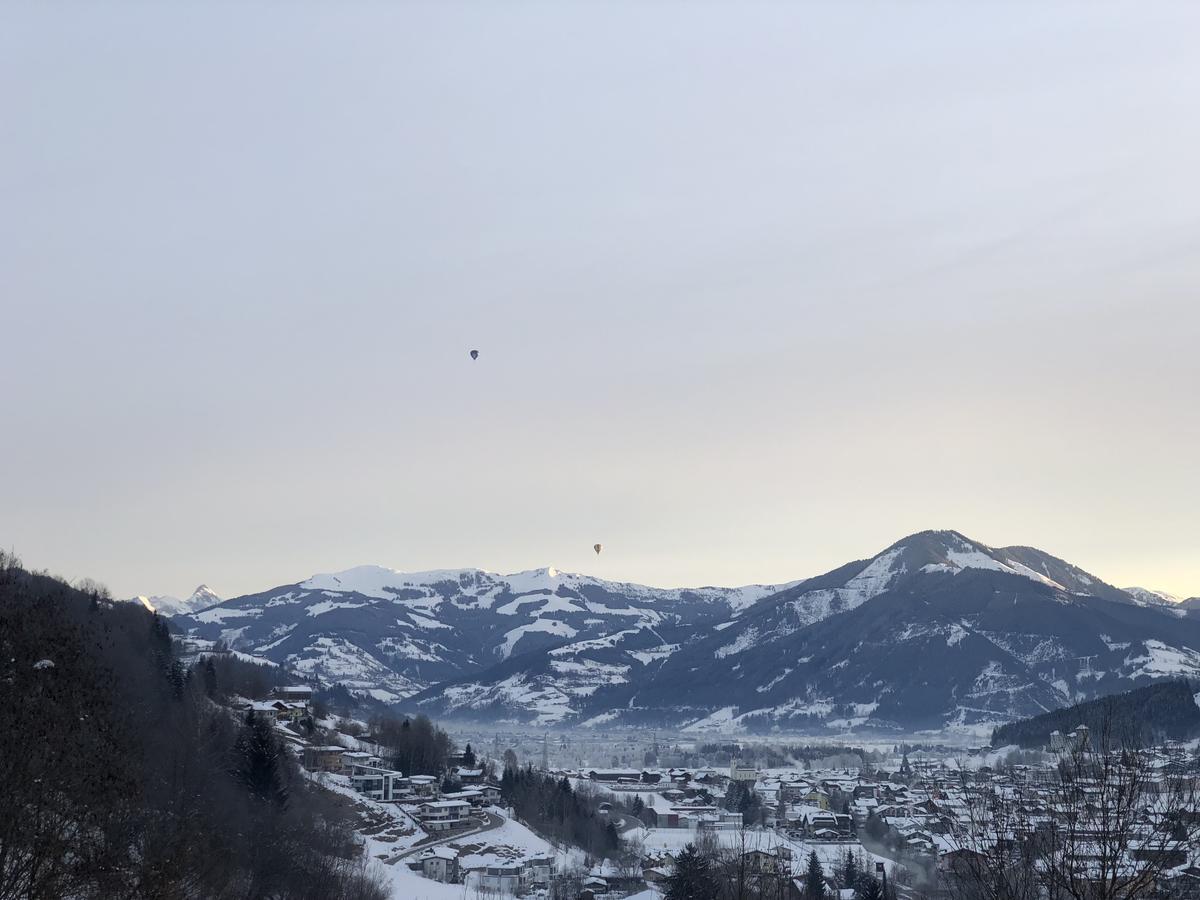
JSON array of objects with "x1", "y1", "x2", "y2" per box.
[{"x1": 413, "y1": 532, "x2": 1200, "y2": 731}]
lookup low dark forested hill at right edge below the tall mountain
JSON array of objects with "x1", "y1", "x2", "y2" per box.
[{"x1": 992, "y1": 679, "x2": 1200, "y2": 748}]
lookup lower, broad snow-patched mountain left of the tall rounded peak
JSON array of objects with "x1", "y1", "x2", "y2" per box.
[{"x1": 176, "y1": 565, "x2": 790, "y2": 701}]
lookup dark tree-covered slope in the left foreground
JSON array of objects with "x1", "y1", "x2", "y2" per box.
[{"x1": 0, "y1": 557, "x2": 385, "y2": 900}]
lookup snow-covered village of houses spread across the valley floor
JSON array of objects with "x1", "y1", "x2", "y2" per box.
[{"x1": 241, "y1": 685, "x2": 1200, "y2": 900}]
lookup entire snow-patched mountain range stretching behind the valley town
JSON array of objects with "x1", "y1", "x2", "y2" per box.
[{"x1": 162, "y1": 532, "x2": 1200, "y2": 733}]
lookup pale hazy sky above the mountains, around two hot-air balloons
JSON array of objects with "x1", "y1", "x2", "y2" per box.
[{"x1": 0, "y1": 0, "x2": 1200, "y2": 607}]
